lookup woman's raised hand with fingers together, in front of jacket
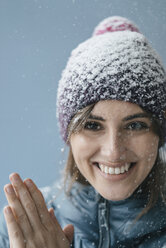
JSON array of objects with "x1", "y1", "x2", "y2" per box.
[{"x1": 4, "y1": 173, "x2": 74, "y2": 248}]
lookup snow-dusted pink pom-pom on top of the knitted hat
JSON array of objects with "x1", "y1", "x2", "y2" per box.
[{"x1": 93, "y1": 16, "x2": 140, "y2": 36}]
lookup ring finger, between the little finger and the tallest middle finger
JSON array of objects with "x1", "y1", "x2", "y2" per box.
[{"x1": 4, "y1": 184, "x2": 32, "y2": 235}]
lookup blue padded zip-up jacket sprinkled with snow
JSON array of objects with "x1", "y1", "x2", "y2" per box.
[{"x1": 0, "y1": 181, "x2": 166, "y2": 248}]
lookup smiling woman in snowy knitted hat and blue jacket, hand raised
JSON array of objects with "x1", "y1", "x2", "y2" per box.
[{"x1": 0, "y1": 17, "x2": 166, "y2": 248}]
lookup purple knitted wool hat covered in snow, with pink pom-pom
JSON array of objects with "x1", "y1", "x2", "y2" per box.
[{"x1": 57, "y1": 16, "x2": 166, "y2": 141}]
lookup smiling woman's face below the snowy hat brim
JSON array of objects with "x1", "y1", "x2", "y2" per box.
[{"x1": 70, "y1": 100, "x2": 159, "y2": 201}]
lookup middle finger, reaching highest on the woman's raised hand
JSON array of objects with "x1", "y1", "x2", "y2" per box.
[{"x1": 10, "y1": 173, "x2": 41, "y2": 231}]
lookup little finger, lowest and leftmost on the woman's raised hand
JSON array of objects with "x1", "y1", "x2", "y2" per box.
[{"x1": 4, "y1": 206, "x2": 25, "y2": 248}]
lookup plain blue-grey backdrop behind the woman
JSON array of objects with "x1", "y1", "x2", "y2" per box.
[{"x1": 0, "y1": 0, "x2": 166, "y2": 207}]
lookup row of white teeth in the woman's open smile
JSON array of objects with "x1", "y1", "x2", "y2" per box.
[{"x1": 99, "y1": 163, "x2": 131, "y2": 175}]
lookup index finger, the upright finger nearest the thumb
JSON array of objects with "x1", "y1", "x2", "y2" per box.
[{"x1": 24, "y1": 179, "x2": 52, "y2": 230}]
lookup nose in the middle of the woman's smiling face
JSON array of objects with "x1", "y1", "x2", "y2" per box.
[{"x1": 101, "y1": 130, "x2": 126, "y2": 163}]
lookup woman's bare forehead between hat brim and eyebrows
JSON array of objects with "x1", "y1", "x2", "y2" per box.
[{"x1": 92, "y1": 100, "x2": 145, "y2": 120}]
